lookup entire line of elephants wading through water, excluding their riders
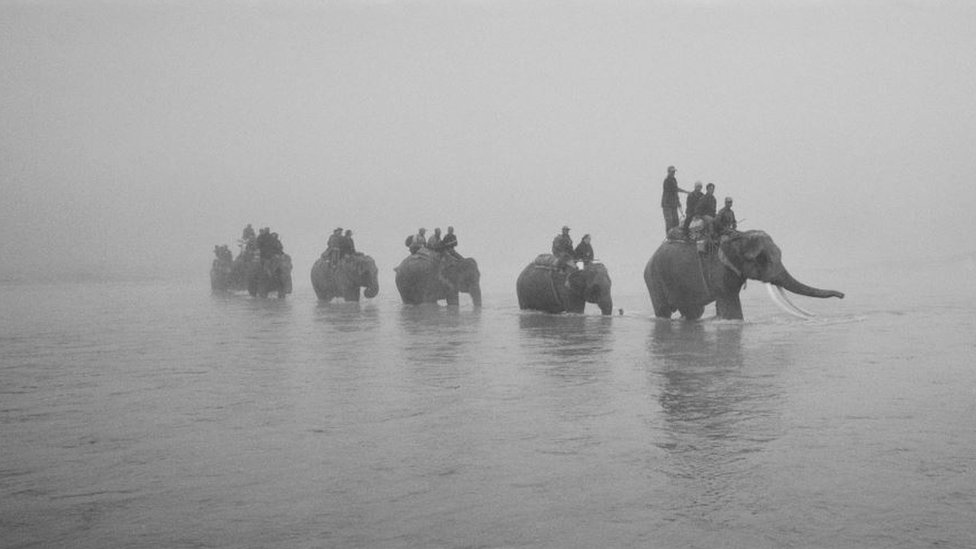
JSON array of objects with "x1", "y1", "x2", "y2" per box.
[{"x1": 210, "y1": 230, "x2": 844, "y2": 320}]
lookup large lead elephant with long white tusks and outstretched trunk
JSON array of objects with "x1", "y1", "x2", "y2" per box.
[{"x1": 644, "y1": 230, "x2": 844, "y2": 320}]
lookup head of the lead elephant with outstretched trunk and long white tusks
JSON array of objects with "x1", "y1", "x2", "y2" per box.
[{"x1": 718, "y1": 231, "x2": 844, "y2": 316}]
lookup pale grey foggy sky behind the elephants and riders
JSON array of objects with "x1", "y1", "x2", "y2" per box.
[{"x1": 0, "y1": 1, "x2": 976, "y2": 292}]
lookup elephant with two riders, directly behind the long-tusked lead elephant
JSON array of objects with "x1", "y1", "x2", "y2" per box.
[{"x1": 515, "y1": 254, "x2": 613, "y2": 315}]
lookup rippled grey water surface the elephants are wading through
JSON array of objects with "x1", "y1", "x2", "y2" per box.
[{"x1": 0, "y1": 284, "x2": 976, "y2": 548}]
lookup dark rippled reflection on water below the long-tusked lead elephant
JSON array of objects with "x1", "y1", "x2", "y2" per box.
[{"x1": 647, "y1": 320, "x2": 788, "y2": 518}]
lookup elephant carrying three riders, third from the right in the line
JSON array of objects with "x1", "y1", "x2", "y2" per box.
[{"x1": 394, "y1": 248, "x2": 481, "y2": 308}]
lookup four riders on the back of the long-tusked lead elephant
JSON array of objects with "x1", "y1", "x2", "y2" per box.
[{"x1": 661, "y1": 166, "x2": 738, "y2": 250}]
